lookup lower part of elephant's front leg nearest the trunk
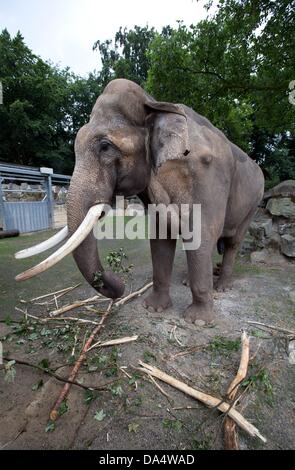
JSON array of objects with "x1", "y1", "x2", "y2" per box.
[{"x1": 143, "y1": 239, "x2": 176, "y2": 312}]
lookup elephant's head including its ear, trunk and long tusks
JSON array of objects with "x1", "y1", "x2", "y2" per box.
[{"x1": 17, "y1": 79, "x2": 189, "y2": 298}]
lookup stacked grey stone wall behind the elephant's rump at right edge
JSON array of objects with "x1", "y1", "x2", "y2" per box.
[{"x1": 241, "y1": 180, "x2": 295, "y2": 264}]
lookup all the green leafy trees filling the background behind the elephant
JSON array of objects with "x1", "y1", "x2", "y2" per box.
[{"x1": 0, "y1": 0, "x2": 295, "y2": 185}]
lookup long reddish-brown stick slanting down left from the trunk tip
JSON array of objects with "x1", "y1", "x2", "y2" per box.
[{"x1": 50, "y1": 300, "x2": 114, "y2": 421}]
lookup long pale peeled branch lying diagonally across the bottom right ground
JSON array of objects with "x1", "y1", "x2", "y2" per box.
[{"x1": 139, "y1": 361, "x2": 266, "y2": 442}]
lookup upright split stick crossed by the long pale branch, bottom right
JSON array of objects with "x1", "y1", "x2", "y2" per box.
[{"x1": 223, "y1": 331, "x2": 250, "y2": 450}]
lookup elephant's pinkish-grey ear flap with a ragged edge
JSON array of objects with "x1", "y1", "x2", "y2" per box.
[{"x1": 145, "y1": 101, "x2": 190, "y2": 169}]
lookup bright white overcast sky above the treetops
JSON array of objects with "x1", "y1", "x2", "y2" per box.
[{"x1": 0, "y1": 0, "x2": 207, "y2": 76}]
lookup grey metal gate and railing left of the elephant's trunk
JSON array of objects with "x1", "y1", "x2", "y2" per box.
[{"x1": 0, "y1": 163, "x2": 71, "y2": 233}]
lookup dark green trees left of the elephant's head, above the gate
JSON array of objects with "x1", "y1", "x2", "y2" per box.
[{"x1": 0, "y1": 30, "x2": 101, "y2": 173}]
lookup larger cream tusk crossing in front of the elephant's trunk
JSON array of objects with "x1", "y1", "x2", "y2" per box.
[{"x1": 15, "y1": 204, "x2": 104, "y2": 281}]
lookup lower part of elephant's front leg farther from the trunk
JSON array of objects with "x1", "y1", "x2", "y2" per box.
[{"x1": 184, "y1": 246, "x2": 214, "y2": 324}]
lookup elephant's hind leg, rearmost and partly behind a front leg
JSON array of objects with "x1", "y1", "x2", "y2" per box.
[{"x1": 215, "y1": 207, "x2": 256, "y2": 291}]
